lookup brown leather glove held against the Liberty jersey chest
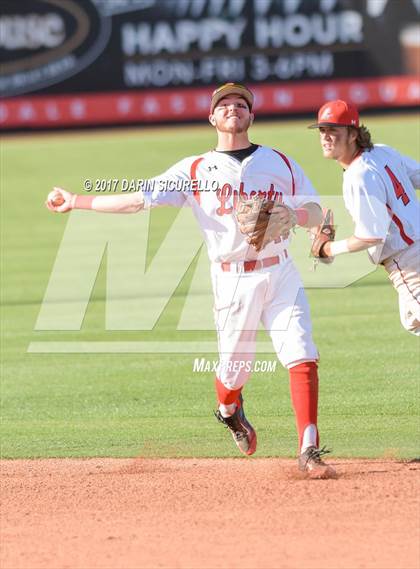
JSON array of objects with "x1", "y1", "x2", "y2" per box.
[{"x1": 235, "y1": 196, "x2": 296, "y2": 251}]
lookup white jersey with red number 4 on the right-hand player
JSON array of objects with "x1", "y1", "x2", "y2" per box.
[{"x1": 343, "y1": 144, "x2": 420, "y2": 263}]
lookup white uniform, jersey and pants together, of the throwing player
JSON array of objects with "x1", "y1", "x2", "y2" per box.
[{"x1": 144, "y1": 146, "x2": 319, "y2": 374}]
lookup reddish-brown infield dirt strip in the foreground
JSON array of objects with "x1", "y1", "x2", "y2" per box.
[{"x1": 0, "y1": 459, "x2": 420, "y2": 569}]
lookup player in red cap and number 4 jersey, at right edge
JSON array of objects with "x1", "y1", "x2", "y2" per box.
[{"x1": 309, "y1": 100, "x2": 420, "y2": 336}]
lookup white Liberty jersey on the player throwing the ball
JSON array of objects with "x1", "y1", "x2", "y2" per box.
[{"x1": 144, "y1": 146, "x2": 319, "y2": 263}]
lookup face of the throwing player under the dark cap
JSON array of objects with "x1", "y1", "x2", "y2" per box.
[{"x1": 210, "y1": 95, "x2": 254, "y2": 134}]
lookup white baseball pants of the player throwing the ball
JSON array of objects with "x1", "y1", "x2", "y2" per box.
[{"x1": 211, "y1": 258, "x2": 319, "y2": 390}]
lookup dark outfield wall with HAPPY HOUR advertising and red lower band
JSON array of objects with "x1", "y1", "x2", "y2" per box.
[{"x1": 0, "y1": 0, "x2": 420, "y2": 129}]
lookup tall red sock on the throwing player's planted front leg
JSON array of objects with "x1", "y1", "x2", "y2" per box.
[{"x1": 289, "y1": 362, "x2": 319, "y2": 450}]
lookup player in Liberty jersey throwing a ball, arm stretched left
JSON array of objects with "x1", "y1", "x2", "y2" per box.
[{"x1": 46, "y1": 83, "x2": 334, "y2": 478}]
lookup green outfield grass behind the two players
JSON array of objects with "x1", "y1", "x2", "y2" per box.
[{"x1": 1, "y1": 115, "x2": 420, "y2": 458}]
